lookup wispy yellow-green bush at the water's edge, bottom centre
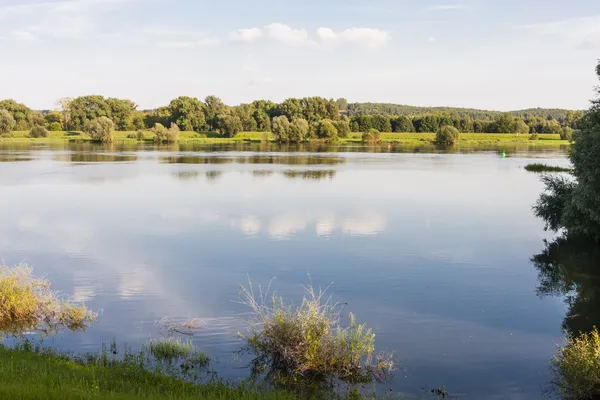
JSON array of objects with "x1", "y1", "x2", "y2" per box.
[{"x1": 241, "y1": 281, "x2": 394, "y2": 385}]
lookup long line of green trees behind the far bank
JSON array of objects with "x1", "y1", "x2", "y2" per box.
[{"x1": 0, "y1": 95, "x2": 583, "y2": 142}]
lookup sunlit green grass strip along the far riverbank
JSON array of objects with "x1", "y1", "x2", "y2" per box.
[{"x1": 0, "y1": 131, "x2": 569, "y2": 147}]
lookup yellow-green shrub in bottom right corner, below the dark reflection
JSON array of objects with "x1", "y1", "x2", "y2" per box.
[{"x1": 551, "y1": 328, "x2": 600, "y2": 400}]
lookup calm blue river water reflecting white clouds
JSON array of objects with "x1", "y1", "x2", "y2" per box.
[{"x1": 0, "y1": 145, "x2": 568, "y2": 399}]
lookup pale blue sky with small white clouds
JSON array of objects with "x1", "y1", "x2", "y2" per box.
[{"x1": 0, "y1": 0, "x2": 600, "y2": 110}]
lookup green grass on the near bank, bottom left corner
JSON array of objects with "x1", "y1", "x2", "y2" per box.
[{"x1": 0, "y1": 346, "x2": 296, "y2": 400}]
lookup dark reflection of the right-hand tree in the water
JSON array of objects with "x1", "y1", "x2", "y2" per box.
[{"x1": 532, "y1": 236, "x2": 600, "y2": 335}]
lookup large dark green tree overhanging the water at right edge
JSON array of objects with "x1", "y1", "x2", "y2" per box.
[{"x1": 534, "y1": 59, "x2": 600, "y2": 241}]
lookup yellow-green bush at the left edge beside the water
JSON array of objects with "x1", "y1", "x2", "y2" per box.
[{"x1": 0, "y1": 265, "x2": 96, "y2": 337}]
